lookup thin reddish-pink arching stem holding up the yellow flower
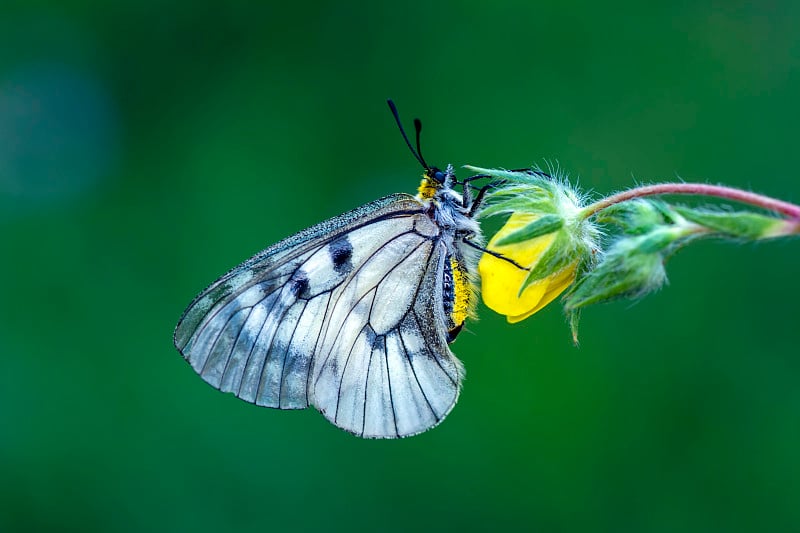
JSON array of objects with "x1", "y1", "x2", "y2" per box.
[{"x1": 580, "y1": 183, "x2": 800, "y2": 221}]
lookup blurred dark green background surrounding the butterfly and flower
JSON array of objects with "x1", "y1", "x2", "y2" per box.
[{"x1": 0, "y1": 0, "x2": 800, "y2": 532}]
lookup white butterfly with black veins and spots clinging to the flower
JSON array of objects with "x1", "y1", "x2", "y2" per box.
[{"x1": 174, "y1": 100, "x2": 486, "y2": 438}]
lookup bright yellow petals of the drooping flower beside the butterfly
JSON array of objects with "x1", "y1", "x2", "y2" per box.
[{"x1": 478, "y1": 213, "x2": 578, "y2": 324}]
